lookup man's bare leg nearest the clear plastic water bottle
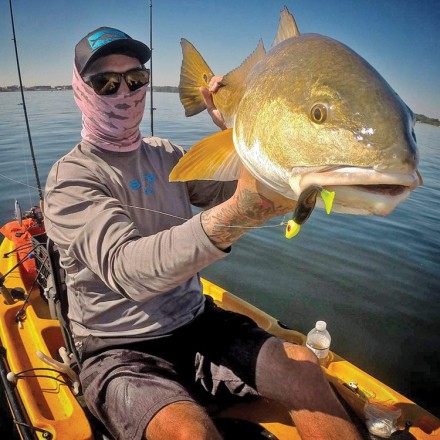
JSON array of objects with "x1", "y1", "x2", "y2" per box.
[{"x1": 256, "y1": 338, "x2": 360, "y2": 440}]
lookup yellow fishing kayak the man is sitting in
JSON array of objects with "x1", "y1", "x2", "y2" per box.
[{"x1": 0, "y1": 222, "x2": 440, "y2": 440}]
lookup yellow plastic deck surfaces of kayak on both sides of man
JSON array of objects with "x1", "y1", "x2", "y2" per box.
[{"x1": 0, "y1": 238, "x2": 440, "y2": 440}]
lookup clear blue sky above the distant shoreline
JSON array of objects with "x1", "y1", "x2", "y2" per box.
[{"x1": 0, "y1": 0, "x2": 440, "y2": 118}]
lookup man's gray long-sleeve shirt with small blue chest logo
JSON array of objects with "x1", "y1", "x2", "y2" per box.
[{"x1": 45, "y1": 137, "x2": 236, "y2": 340}]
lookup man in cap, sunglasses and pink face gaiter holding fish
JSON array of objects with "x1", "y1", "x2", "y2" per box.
[{"x1": 45, "y1": 28, "x2": 357, "y2": 440}]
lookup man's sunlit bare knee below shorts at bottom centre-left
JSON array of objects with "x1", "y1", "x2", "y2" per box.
[{"x1": 145, "y1": 401, "x2": 221, "y2": 440}]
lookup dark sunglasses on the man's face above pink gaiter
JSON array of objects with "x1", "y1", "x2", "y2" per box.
[{"x1": 83, "y1": 67, "x2": 150, "y2": 95}]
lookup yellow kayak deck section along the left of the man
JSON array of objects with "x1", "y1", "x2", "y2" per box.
[{"x1": 0, "y1": 235, "x2": 93, "y2": 440}]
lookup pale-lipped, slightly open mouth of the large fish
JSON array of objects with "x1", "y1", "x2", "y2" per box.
[{"x1": 289, "y1": 166, "x2": 422, "y2": 215}]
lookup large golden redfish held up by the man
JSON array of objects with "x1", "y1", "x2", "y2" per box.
[{"x1": 170, "y1": 8, "x2": 421, "y2": 219}]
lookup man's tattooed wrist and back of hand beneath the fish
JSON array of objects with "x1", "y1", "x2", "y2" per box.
[{"x1": 201, "y1": 190, "x2": 276, "y2": 249}]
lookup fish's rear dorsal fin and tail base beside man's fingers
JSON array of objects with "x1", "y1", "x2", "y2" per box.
[{"x1": 214, "y1": 40, "x2": 266, "y2": 126}]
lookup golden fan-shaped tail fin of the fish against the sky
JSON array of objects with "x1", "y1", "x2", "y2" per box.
[{"x1": 179, "y1": 38, "x2": 214, "y2": 116}]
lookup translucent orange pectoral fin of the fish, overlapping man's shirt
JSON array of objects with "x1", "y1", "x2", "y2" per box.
[{"x1": 169, "y1": 128, "x2": 241, "y2": 182}]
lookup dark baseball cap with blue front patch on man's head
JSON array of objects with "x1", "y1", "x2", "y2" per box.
[{"x1": 75, "y1": 26, "x2": 151, "y2": 74}]
